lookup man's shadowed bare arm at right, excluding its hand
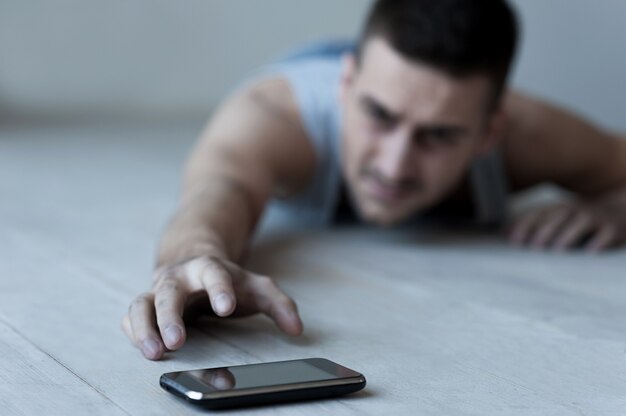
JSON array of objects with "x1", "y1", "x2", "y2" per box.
[{"x1": 503, "y1": 93, "x2": 626, "y2": 196}]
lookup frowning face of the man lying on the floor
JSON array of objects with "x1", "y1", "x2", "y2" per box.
[{"x1": 341, "y1": 38, "x2": 495, "y2": 225}]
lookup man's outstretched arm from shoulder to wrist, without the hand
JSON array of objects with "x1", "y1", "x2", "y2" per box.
[{"x1": 158, "y1": 80, "x2": 314, "y2": 264}]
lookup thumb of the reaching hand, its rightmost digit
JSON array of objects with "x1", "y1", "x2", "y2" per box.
[{"x1": 250, "y1": 274, "x2": 302, "y2": 335}]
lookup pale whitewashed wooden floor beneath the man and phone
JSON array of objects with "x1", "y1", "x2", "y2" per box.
[{"x1": 0, "y1": 119, "x2": 626, "y2": 415}]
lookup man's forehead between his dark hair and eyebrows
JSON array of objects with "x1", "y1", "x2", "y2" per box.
[{"x1": 356, "y1": 37, "x2": 490, "y2": 122}]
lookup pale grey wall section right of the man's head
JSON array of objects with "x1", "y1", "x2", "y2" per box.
[{"x1": 512, "y1": 0, "x2": 626, "y2": 132}]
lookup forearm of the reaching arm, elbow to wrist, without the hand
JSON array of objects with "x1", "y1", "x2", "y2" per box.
[{"x1": 157, "y1": 177, "x2": 263, "y2": 265}]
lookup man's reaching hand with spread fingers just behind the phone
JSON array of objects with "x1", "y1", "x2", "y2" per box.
[{"x1": 122, "y1": 256, "x2": 302, "y2": 360}]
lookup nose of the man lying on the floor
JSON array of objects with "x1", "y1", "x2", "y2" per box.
[{"x1": 378, "y1": 129, "x2": 412, "y2": 182}]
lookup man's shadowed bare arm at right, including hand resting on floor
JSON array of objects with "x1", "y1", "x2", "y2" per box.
[{"x1": 503, "y1": 93, "x2": 626, "y2": 251}]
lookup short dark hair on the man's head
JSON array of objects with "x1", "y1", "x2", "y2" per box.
[{"x1": 357, "y1": 0, "x2": 518, "y2": 109}]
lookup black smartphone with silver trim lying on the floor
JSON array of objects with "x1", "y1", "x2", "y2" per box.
[{"x1": 160, "y1": 358, "x2": 365, "y2": 409}]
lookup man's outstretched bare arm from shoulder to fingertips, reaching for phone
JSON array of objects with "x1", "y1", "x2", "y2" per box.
[{"x1": 123, "y1": 80, "x2": 315, "y2": 359}]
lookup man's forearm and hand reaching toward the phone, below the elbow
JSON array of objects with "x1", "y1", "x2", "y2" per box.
[{"x1": 127, "y1": 175, "x2": 302, "y2": 360}]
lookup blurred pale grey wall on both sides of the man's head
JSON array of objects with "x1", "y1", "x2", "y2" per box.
[{"x1": 0, "y1": 0, "x2": 626, "y2": 131}]
